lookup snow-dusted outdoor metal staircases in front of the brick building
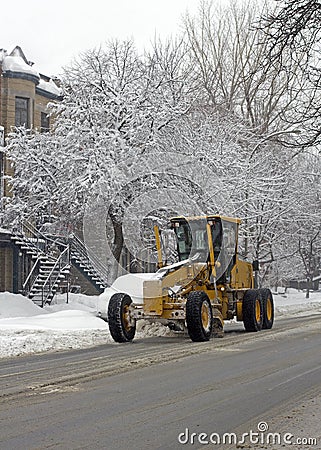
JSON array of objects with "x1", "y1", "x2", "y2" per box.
[{"x1": 11, "y1": 222, "x2": 108, "y2": 306}]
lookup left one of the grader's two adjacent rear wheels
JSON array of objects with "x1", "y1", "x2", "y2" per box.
[{"x1": 242, "y1": 289, "x2": 263, "y2": 331}]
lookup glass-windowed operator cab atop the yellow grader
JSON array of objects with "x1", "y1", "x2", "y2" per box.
[{"x1": 171, "y1": 216, "x2": 241, "y2": 280}]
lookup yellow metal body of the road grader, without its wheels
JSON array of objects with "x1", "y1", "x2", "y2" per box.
[{"x1": 129, "y1": 215, "x2": 254, "y2": 326}]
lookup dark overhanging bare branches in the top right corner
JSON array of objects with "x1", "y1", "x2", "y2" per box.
[{"x1": 257, "y1": 0, "x2": 321, "y2": 147}]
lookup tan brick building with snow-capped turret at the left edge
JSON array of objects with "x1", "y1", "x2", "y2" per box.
[{"x1": 0, "y1": 46, "x2": 61, "y2": 292}]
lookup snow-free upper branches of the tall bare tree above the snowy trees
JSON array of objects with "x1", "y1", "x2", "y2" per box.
[{"x1": 185, "y1": 1, "x2": 299, "y2": 137}]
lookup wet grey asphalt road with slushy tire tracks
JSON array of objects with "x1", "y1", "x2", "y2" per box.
[{"x1": 0, "y1": 316, "x2": 321, "y2": 450}]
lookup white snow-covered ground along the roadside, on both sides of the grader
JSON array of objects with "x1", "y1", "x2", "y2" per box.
[{"x1": 0, "y1": 289, "x2": 321, "y2": 358}]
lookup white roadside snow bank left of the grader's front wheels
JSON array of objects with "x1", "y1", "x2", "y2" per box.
[{"x1": 0, "y1": 292, "x2": 113, "y2": 357}]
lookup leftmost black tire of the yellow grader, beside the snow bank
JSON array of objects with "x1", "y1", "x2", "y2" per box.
[{"x1": 108, "y1": 293, "x2": 136, "y2": 343}]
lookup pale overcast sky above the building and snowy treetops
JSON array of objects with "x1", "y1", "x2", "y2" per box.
[{"x1": 0, "y1": 0, "x2": 199, "y2": 75}]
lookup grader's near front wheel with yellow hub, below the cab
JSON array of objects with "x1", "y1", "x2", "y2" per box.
[{"x1": 186, "y1": 291, "x2": 213, "y2": 342}]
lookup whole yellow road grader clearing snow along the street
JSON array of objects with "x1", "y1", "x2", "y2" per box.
[{"x1": 107, "y1": 215, "x2": 274, "y2": 342}]
